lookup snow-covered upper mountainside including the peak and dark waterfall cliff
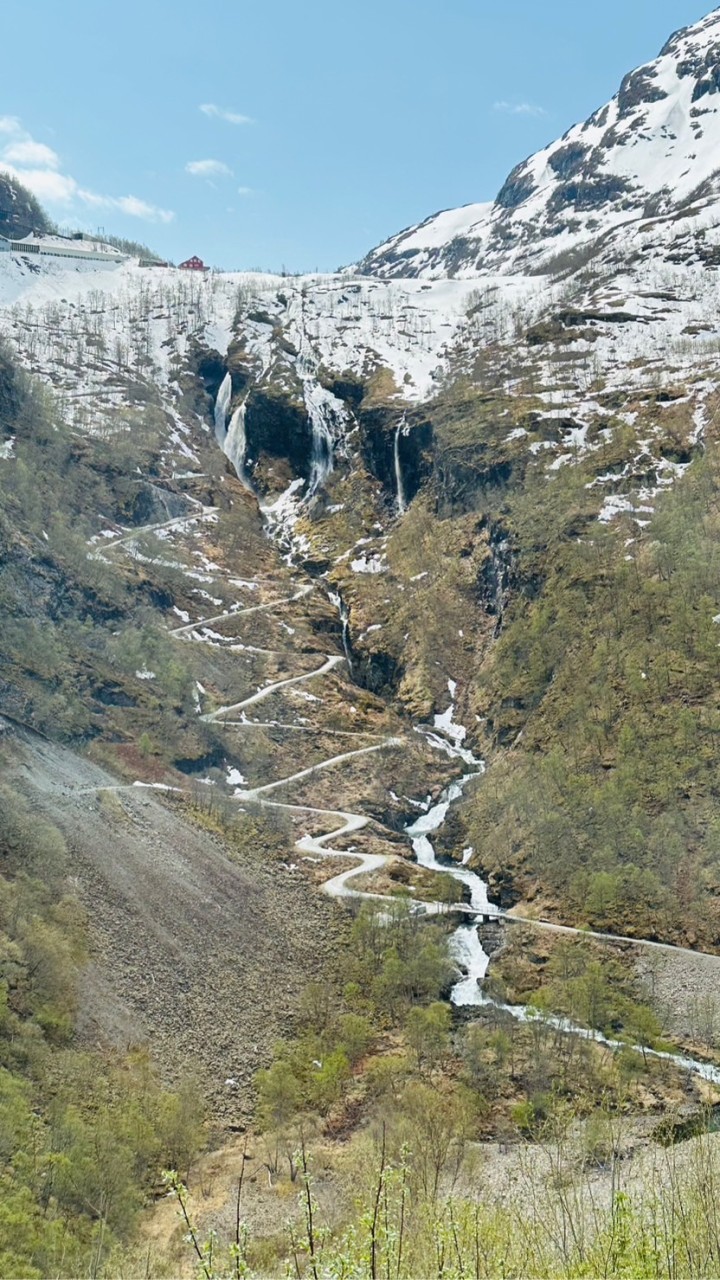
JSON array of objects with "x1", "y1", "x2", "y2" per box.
[{"x1": 0, "y1": 9, "x2": 720, "y2": 564}]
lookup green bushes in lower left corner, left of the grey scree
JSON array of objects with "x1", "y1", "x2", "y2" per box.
[{"x1": 0, "y1": 787, "x2": 202, "y2": 1280}]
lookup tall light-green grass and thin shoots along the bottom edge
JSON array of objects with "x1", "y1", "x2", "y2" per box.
[{"x1": 168, "y1": 1131, "x2": 720, "y2": 1280}]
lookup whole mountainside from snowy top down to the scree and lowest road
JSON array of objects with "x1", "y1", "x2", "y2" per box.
[{"x1": 0, "y1": 5, "x2": 720, "y2": 1116}]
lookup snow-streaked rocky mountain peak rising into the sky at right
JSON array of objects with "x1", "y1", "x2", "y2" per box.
[{"x1": 360, "y1": 9, "x2": 720, "y2": 279}]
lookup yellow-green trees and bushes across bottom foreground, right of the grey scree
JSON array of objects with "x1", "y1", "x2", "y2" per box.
[{"x1": 165, "y1": 905, "x2": 720, "y2": 1280}]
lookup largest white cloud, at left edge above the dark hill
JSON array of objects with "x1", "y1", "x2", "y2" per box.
[{"x1": 0, "y1": 115, "x2": 176, "y2": 223}]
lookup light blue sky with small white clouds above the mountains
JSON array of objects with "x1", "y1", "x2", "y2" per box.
[{"x1": 0, "y1": 0, "x2": 712, "y2": 270}]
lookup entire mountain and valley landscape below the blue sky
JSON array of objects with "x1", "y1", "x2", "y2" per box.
[{"x1": 8, "y1": 10, "x2": 720, "y2": 1280}]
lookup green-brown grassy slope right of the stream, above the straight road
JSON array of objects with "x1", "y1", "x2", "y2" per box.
[{"x1": 311, "y1": 352, "x2": 720, "y2": 947}]
